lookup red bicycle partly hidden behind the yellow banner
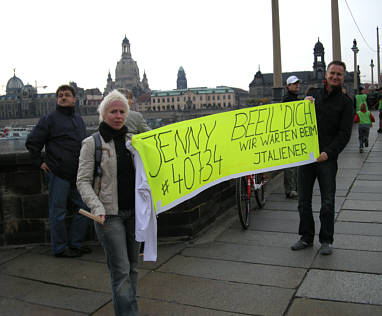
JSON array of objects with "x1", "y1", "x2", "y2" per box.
[{"x1": 236, "y1": 173, "x2": 266, "y2": 229}]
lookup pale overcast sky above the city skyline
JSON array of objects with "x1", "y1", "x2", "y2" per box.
[{"x1": 0, "y1": 0, "x2": 382, "y2": 94}]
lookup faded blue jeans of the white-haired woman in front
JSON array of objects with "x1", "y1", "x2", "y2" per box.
[{"x1": 94, "y1": 210, "x2": 140, "y2": 316}]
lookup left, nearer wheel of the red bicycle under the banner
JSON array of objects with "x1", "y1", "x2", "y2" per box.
[{"x1": 236, "y1": 177, "x2": 251, "y2": 229}]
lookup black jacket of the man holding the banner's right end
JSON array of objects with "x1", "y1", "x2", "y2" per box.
[{"x1": 308, "y1": 88, "x2": 353, "y2": 160}]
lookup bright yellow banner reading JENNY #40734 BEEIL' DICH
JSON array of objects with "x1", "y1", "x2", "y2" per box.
[{"x1": 132, "y1": 100, "x2": 319, "y2": 214}]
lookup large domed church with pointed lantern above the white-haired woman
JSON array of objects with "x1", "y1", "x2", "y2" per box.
[{"x1": 104, "y1": 35, "x2": 150, "y2": 97}]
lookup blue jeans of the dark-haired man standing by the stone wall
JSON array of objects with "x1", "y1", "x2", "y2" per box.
[{"x1": 46, "y1": 172, "x2": 89, "y2": 254}]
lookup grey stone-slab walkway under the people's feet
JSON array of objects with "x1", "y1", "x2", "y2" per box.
[{"x1": 0, "y1": 113, "x2": 382, "y2": 316}]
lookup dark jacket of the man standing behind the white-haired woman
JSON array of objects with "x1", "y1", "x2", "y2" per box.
[{"x1": 25, "y1": 105, "x2": 86, "y2": 181}]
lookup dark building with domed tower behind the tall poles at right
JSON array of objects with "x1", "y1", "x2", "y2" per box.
[{"x1": 249, "y1": 39, "x2": 359, "y2": 100}]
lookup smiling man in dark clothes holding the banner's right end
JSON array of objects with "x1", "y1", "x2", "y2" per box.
[{"x1": 291, "y1": 61, "x2": 353, "y2": 255}]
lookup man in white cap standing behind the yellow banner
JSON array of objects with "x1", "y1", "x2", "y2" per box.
[{"x1": 283, "y1": 76, "x2": 300, "y2": 199}]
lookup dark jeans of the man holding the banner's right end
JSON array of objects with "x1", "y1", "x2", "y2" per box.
[{"x1": 297, "y1": 160, "x2": 338, "y2": 244}]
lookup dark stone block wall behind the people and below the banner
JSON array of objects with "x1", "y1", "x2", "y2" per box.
[{"x1": 0, "y1": 152, "x2": 235, "y2": 246}]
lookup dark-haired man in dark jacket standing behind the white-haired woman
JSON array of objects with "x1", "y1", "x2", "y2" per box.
[{"x1": 25, "y1": 85, "x2": 91, "y2": 257}]
